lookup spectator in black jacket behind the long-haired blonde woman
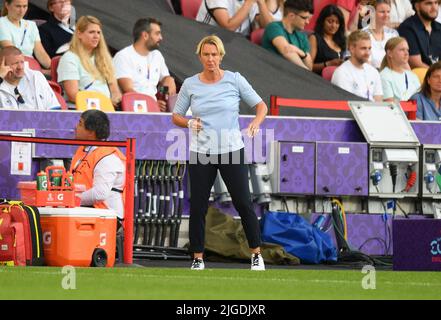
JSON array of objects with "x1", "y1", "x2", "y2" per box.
[{"x1": 38, "y1": 0, "x2": 75, "y2": 58}]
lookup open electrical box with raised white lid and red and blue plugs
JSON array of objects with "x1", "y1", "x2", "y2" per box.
[{"x1": 349, "y1": 102, "x2": 420, "y2": 205}]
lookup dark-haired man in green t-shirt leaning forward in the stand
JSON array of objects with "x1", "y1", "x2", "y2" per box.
[{"x1": 262, "y1": 0, "x2": 313, "y2": 70}]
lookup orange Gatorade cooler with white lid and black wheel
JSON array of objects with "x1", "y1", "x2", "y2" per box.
[{"x1": 38, "y1": 207, "x2": 116, "y2": 267}]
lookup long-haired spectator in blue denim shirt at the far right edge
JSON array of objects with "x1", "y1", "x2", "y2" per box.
[{"x1": 411, "y1": 61, "x2": 441, "y2": 121}]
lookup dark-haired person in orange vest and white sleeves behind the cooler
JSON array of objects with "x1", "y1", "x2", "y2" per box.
[{"x1": 70, "y1": 109, "x2": 126, "y2": 222}]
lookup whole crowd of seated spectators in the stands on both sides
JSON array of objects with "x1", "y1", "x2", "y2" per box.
[{"x1": 0, "y1": 0, "x2": 441, "y2": 120}]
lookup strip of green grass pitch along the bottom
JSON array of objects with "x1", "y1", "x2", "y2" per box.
[{"x1": 0, "y1": 267, "x2": 441, "y2": 300}]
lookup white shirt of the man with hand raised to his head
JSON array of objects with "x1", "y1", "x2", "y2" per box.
[{"x1": 0, "y1": 68, "x2": 60, "y2": 110}]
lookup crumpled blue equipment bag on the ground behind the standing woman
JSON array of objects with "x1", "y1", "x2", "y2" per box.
[{"x1": 260, "y1": 211, "x2": 337, "y2": 264}]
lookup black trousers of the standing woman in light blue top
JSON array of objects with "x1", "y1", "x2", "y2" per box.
[{"x1": 189, "y1": 149, "x2": 261, "y2": 252}]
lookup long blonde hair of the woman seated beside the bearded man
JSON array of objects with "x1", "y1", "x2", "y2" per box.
[{"x1": 70, "y1": 16, "x2": 115, "y2": 83}]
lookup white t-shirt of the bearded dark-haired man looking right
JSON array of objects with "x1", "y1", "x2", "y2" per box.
[{"x1": 113, "y1": 45, "x2": 170, "y2": 99}]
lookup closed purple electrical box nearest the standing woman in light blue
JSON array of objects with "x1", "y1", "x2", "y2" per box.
[{"x1": 267, "y1": 141, "x2": 315, "y2": 195}]
